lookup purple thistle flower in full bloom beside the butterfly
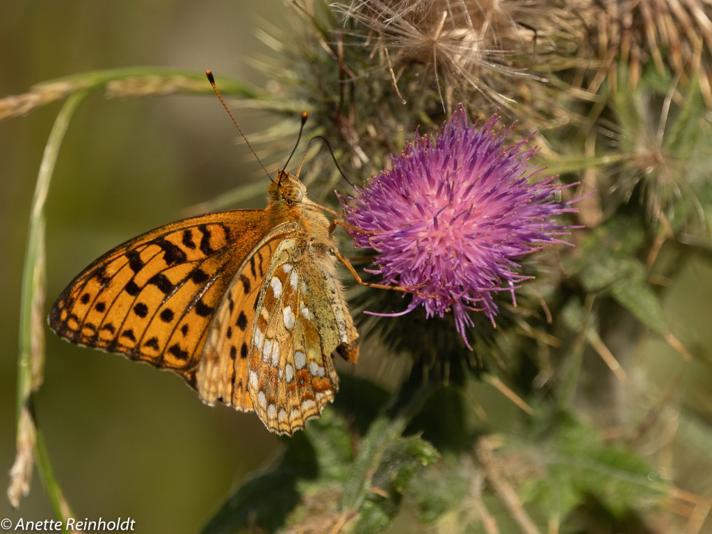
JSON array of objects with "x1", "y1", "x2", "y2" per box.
[{"x1": 344, "y1": 108, "x2": 575, "y2": 348}]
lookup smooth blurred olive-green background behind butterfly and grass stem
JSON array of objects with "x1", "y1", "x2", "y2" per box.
[{"x1": 0, "y1": 0, "x2": 712, "y2": 533}]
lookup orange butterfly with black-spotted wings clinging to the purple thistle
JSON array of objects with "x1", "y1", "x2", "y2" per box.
[{"x1": 49, "y1": 172, "x2": 358, "y2": 434}]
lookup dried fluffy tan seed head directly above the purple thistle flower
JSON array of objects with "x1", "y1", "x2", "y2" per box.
[{"x1": 332, "y1": 0, "x2": 566, "y2": 111}]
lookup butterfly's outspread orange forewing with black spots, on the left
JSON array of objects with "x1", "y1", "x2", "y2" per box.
[{"x1": 49, "y1": 210, "x2": 270, "y2": 372}]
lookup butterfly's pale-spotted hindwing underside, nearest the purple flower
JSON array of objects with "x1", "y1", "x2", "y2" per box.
[{"x1": 248, "y1": 237, "x2": 358, "y2": 434}]
